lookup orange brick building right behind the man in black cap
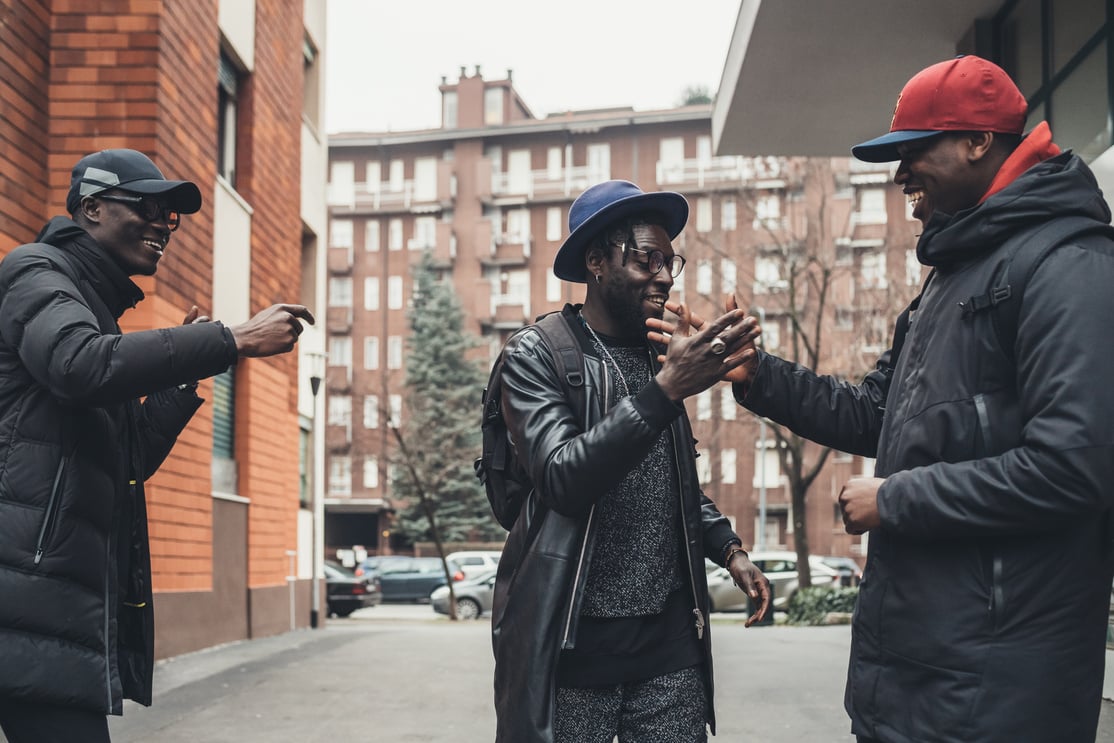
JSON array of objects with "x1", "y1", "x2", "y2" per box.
[{"x1": 0, "y1": 0, "x2": 325, "y2": 656}]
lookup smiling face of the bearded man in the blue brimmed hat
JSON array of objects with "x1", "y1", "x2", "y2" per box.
[{"x1": 588, "y1": 219, "x2": 674, "y2": 338}]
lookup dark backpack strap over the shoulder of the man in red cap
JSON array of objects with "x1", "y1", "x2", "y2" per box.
[{"x1": 959, "y1": 216, "x2": 1114, "y2": 363}]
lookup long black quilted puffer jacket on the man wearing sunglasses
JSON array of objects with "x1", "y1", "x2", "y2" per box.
[{"x1": 0, "y1": 217, "x2": 236, "y2": 714}]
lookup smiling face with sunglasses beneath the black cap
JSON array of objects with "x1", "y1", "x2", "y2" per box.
[{"x1": 79, "y1": 192, "x2": 170, "y2": 276}]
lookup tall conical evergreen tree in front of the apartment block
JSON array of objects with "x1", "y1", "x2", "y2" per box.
[{"x1": 391, "y1": 252, "x2": 504, "y2": 545}]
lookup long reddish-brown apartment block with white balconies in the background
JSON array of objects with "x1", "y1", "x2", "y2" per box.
[{"x1": 325, "y1": 68, "x2": 921, "y2": 563}]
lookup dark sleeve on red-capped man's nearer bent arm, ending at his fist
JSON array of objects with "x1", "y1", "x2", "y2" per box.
[{"x1": 878, "y1": 244, "x2": 1114, "y2": 539}]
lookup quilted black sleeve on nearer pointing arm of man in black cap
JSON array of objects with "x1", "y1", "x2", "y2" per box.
[{"x1": 0, "y1": 253, "x2": 236, "y2": 405}]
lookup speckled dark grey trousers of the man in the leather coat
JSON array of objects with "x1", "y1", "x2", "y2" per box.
[{"x1": 554, "y1": 666, "x2": 707, "y2": 743}]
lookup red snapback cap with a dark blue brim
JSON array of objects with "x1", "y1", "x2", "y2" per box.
[{"x1": 851, "y1": 55, "x2": 1028, "y2": 163}]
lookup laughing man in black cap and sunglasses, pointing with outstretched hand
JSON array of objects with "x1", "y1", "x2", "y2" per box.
[{"x1": 0, "y1": 149, "x2": 313, "y2": 743}]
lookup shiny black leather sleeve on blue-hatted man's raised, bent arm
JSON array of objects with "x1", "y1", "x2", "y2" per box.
[{"x1": 502, "y1": 331, "x2": 684, "y2": 517}]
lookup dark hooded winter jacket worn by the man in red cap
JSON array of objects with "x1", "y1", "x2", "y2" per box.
[{"x1": 736, "y1": 154, "x2": 1114, "y2": 743}]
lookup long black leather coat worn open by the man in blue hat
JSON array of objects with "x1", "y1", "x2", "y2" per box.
[{"x1": 491, "y1": 305, "x2": 737, "y2": 743}]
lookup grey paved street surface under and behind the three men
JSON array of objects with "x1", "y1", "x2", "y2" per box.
[{"x1": 0, "y1": 605, "x2": 1114, "y2": 743}]
